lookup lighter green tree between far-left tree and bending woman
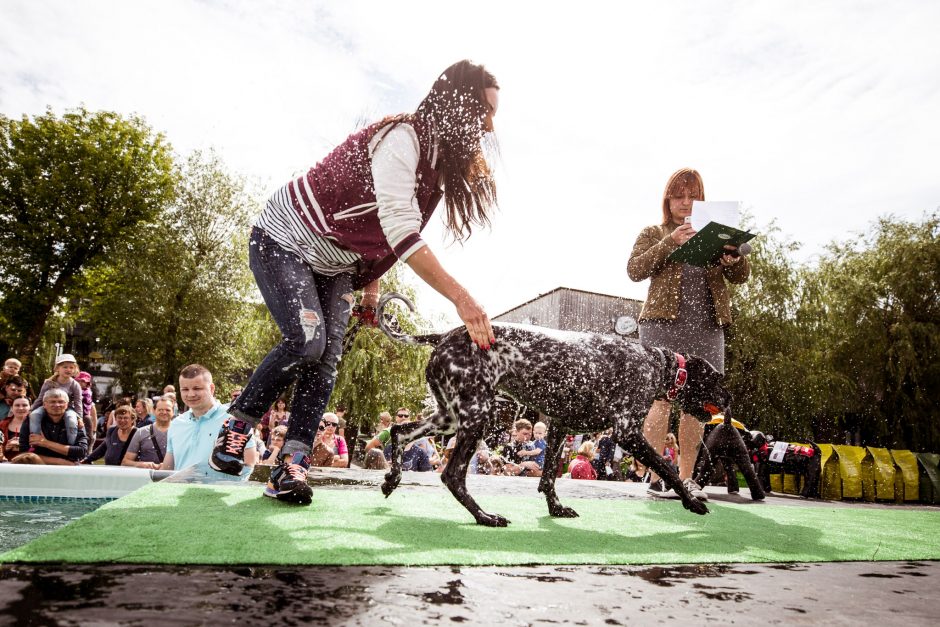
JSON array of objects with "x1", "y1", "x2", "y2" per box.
[{"x1": 85, "y1": 153, "x2": 276, "y2": 389}]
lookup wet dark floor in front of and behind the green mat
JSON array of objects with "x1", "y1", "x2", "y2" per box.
[{"x1": 0, "y1": 469, "x2": 940, "y2": 625}]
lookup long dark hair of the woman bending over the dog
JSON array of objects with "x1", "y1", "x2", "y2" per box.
[{"x1": 387, "y1": 59, "x2": 499, "y2": 241}]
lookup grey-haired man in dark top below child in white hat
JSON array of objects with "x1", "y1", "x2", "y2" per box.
[{"x1": 20, "y1": 387, "x2": 88, "y2": 466}]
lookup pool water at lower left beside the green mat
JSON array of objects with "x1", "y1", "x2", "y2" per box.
[{"x1": 0, "y1": 499, "x2": 110, "y2": 553}]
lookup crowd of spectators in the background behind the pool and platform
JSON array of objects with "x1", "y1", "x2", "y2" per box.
[{"x1": 0, "y1": 353, "x2": 679, "y2": 482}]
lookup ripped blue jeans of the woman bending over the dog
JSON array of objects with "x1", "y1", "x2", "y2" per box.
[{"x1": 229, "y1": 227, "x2": 353, "y2": 445}]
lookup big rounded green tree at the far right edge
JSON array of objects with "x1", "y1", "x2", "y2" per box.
[{"x1": 819, "y1": 211, "x2": 940, "y2": 450}]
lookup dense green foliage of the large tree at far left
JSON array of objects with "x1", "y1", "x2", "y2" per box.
[{"x1": 0, "y1": 108, "x2": 174, "y2": 361}]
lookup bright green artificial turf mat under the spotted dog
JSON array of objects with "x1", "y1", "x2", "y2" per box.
[{"x1": 0, "y1": 483, "x2": 940, "y2": 565}]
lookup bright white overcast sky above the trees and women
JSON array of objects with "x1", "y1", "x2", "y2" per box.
[{"x1": 0, "y1": 0, "x2": 940, "y2": 321}]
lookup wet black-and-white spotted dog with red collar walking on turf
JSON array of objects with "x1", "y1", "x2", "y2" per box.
[{"x1": 378, "y1": 294, "x2": 731, "y2": 527}]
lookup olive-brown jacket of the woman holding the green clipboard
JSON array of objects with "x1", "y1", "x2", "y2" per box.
[{"x1": 627, "y1": 222, "x2": 751, "y2": 326}]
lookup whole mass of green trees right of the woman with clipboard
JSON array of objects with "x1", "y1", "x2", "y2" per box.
[{"x1": 727, "y1": 212, "x2": 940, "y2": 450}]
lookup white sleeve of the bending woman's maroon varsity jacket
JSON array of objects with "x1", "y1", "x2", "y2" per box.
[{"x1": 369, "y1": 124, "x2": 425, "y2": 261}]
